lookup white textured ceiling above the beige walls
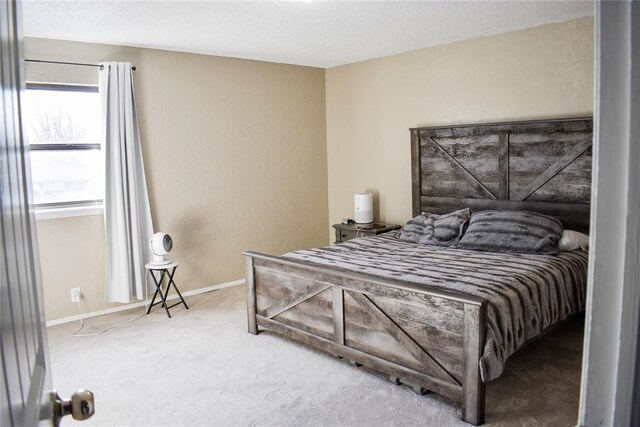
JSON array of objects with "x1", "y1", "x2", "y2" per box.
[{"x1": 23, "y1": 0, "x2": 593, "y2": 67}]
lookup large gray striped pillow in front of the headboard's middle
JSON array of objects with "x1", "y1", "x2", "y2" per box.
[{"x1": 456, "y1": 211, "x2": 564, "y2": 254}]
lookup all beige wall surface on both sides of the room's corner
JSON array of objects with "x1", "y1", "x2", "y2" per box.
[{"x1": 25, "y1": 18, "x2": 593, "y2": 319}]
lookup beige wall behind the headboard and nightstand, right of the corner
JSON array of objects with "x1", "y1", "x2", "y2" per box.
[{"x1": 326, "y1": 18, "x2": 594, "y2": 237}]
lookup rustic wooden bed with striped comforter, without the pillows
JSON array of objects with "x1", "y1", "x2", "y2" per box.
[{"x1": 245, "y1": 119, "x2": 592, "y2": 425}]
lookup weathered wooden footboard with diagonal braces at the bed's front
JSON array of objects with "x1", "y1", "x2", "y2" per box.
[{"x1": 245, "y1": 252, "x2": 486, "y2": 425}]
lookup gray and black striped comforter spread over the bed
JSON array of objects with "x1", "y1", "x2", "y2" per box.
[{"x1": 285, "y1": 232, "x2": 588, "y2": 382}]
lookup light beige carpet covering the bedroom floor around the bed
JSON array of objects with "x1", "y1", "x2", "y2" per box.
[{"x1": 48, "y1": 287, "x2": 582, "y2": 426}]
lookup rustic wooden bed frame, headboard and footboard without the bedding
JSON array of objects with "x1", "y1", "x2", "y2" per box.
[{"x1": 245, "y1": 118, "x2": 592, "y2": 425}]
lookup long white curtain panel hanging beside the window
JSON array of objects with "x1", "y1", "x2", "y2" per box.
[{"x1": 100, "y1": 62, "x2": 153, "y2": 303}]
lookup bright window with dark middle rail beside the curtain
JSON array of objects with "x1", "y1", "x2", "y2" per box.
[{"x1": 23, "y1": 84, "x2": 104, "y2": 208}]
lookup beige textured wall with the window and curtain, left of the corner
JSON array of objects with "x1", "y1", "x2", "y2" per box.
[{"x1": 25, "y1": 38, "x2": 328, "y2": 319}]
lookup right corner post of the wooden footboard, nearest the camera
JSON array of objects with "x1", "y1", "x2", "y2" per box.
[{"x1": 462, "y1": 304, "x2": 486, "y2": 426}]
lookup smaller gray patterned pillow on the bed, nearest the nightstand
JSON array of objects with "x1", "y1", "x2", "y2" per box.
[{"x1": 398, "y1": 208, "x2": 471, "y2": 246}]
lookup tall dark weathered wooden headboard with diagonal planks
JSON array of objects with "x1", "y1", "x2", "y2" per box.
[{"x1": 411, "y1": 118, "x2": 593, "y2": 231}]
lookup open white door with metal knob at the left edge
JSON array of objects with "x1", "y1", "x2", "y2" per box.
[{"x1": 0, "y1": 0, "x2": 93, "y2": 426}]
